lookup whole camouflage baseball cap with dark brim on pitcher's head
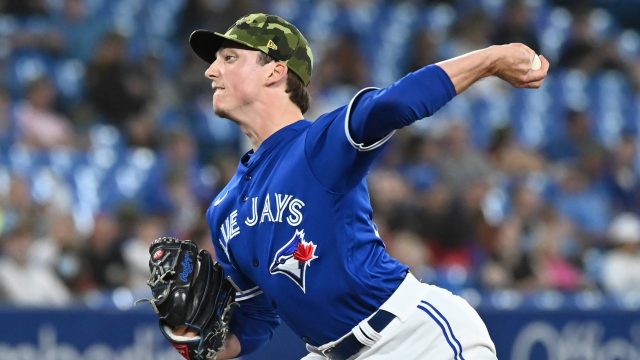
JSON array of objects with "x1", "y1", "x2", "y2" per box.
[{"x1": 189, "y1": 13, "x2": 313, "y2": 85}]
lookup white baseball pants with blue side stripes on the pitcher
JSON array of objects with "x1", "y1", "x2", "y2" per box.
[{"x1": 303, "y1": 273, "x2": 497, "y2": 360}]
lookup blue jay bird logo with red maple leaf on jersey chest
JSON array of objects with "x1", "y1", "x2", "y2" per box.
[{"x1": 269, "y1": 230, "x2": 318, "y2": 293}]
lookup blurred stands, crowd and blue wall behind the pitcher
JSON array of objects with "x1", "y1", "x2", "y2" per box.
[{"x1": 0, "y1": 0, "x2": 640, "y2": 360}]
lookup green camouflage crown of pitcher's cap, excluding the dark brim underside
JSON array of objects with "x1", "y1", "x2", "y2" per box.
[{"x1": 194, "y1": 13, "x2": 313, "y2": 85}]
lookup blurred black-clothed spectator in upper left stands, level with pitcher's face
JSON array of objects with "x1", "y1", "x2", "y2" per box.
[{"x1": 86, "y1": 32, "x2": 151, "y2": 129}]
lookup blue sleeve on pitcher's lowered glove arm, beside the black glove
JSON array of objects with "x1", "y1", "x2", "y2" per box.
[{"x1": 212, "y1": 233, "x2": 280, "y2": 355}]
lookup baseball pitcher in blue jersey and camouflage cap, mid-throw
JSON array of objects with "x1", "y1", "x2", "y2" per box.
[{"x1": 145, "y1": 14, "x2": 549, "y2": 360}]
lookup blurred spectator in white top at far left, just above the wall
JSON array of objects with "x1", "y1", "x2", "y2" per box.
[{"x1": 0, "y1": 223, "x2": 71, "y2": 307}]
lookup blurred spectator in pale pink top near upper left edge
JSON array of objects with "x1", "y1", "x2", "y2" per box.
[{"x1": 16, "y1": 76, "x2": 73, "y2": 150}]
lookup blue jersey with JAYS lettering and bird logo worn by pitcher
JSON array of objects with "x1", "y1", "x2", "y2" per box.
[{"x1": 207, "y1": 64, "x2": 453, "y2": 353}]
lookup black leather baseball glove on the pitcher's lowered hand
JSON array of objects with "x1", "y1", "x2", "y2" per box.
[{"x1": 147, "y1": 237, "x2": 236, "y2": 360}]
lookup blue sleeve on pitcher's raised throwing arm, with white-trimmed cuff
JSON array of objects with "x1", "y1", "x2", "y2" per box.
[{"x1": 305, "y1": 65, "x2": 456, "y2": 192}]
